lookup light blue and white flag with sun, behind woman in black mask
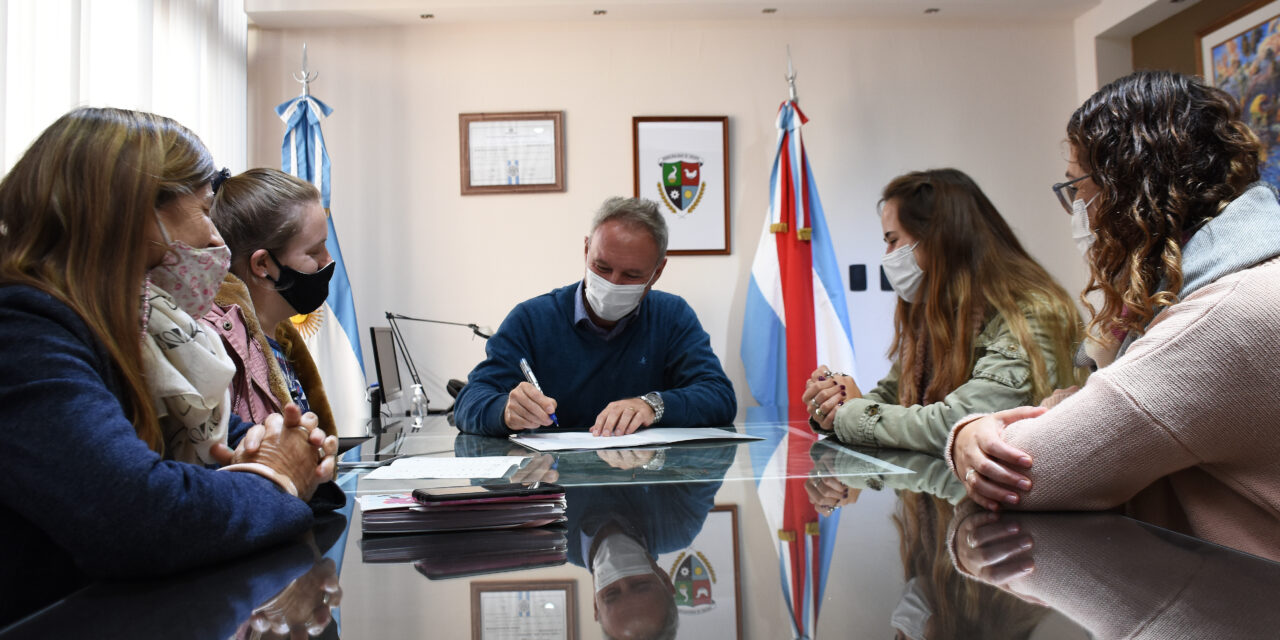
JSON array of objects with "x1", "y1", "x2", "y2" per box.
[{"x1": 275, "y1": 93, "x2": 369, "y2": 435}]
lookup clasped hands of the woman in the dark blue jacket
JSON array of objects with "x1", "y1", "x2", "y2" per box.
[{"x1": 210, "y1": 402, "x2": 338, "y2": 500}]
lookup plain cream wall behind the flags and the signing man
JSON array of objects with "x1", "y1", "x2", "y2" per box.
[{"x1": 248, "y1": 18, "x2": 1084, "y2": 414}]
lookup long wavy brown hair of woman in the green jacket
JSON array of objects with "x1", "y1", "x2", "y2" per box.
[{"x1": 881, "y1": 169, "x2": 1080, "y2": 406}]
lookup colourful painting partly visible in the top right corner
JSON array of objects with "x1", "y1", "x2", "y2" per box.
[{"x1": 1197, "y1": 0, "x2": 1280, "y2": 187}]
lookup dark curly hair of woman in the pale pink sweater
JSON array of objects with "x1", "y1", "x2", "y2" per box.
[{"x1": 1066, "y1": 72, "x2": 1261, "y2": 335}]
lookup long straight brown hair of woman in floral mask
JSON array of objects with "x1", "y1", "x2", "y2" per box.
[{"x1": 0, "y1": 108, "x2": 215, "y2": 452}]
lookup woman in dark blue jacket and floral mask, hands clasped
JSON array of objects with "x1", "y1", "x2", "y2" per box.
[{"x1": 0, "y1": 109, "x2": 337, "y2": 626}]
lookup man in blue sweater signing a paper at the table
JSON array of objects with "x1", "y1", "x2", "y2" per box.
[{"x1": 454, "y1": 197, "x2": 737, "y2": 435}]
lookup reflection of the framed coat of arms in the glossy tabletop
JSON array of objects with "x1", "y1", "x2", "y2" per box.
[{"x1": 658, "y1": 504, "x2": 742, "y2": 640}]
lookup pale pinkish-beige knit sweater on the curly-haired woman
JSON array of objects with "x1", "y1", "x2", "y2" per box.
[{"x1": 948, "y1": 259, "x2": 1280, "y2": 559}]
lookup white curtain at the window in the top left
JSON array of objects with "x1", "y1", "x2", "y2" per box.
[{"x1": 0, "y1": 0, "x2": 248, "y2": 173}]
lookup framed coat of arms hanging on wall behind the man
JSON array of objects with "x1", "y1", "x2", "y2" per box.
[{"x1": 631, "y1": 115, "x2": 730, "y2": 255}]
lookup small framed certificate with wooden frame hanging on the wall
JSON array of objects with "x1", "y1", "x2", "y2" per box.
[{"x1": 458, "y1": 111, "x2": 564, "y2": 196}]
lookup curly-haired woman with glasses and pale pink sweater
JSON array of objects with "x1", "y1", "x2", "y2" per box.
[{"x1": 946, "y1": 72, "x2": 1280, "y2": 559}]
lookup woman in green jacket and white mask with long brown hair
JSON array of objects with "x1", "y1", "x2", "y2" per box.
[{"x1": 801, "y1": 169, "x2": 1083, "y2": 456}]
